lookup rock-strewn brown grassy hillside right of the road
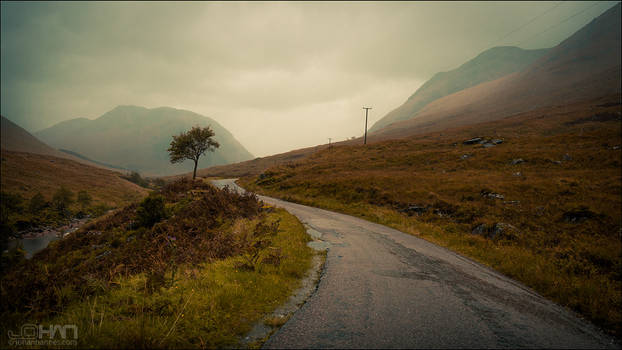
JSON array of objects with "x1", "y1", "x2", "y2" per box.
[{"x1": 240, "y1": 95, "x2": 622, "y2": 337}]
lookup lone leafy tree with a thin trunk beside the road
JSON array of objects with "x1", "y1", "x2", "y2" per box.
[{"x1": 168, "y1": 126, "x2": 220, "y2": 180}]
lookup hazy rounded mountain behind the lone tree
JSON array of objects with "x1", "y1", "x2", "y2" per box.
[{"x1": 36, "y1": 106, "x2": 253, "y2": 175}]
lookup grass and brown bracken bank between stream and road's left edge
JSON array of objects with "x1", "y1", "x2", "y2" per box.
[{"x1": 0, "y1": 181, "x2": 314, "y2": 348}]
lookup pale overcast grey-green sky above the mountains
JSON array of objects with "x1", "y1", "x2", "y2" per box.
[{"x1": 0, "y1": 1, "x2": 617, "y2": 156}]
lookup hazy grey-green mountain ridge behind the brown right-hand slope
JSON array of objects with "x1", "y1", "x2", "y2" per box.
[{"x1": 369, "y1": 46, "x2": 548, "y2": 132}]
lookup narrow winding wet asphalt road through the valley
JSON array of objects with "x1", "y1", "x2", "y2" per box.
[{"x1": 214, "y1": 179, "x2": 619, "y2": 348}]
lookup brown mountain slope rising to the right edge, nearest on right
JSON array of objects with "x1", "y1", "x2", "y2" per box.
[{"x1": 369, "y1": 3, "x2": 621, "y2": 140}]
